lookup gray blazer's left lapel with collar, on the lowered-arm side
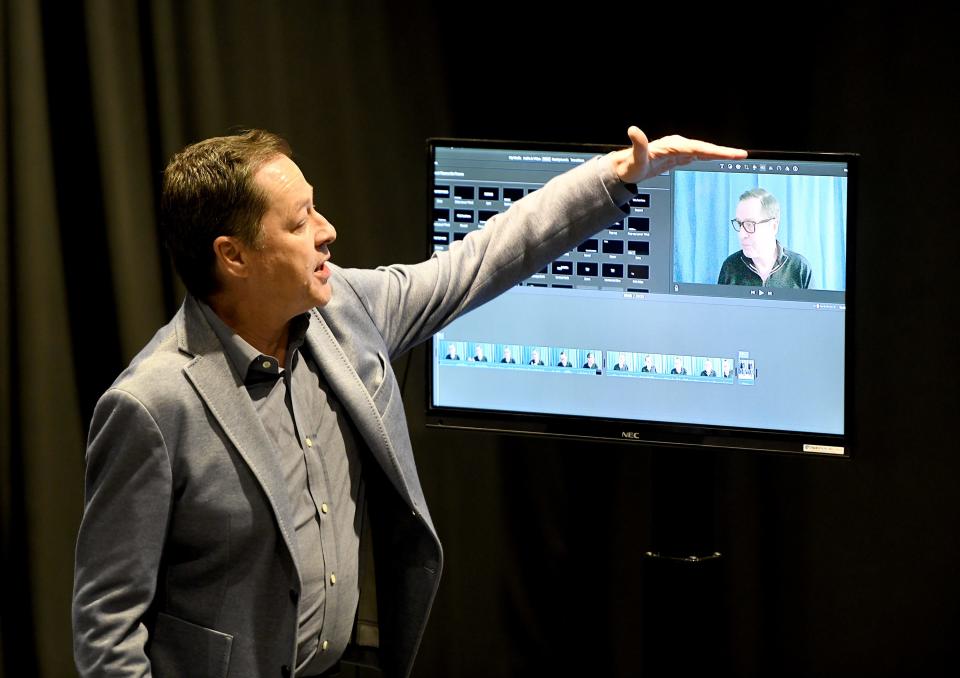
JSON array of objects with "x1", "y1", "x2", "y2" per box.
[{"x1": 177, "y1": 295, "x2": 300, "y2": 571}]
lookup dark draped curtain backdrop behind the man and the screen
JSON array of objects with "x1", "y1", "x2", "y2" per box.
[{"x1": 0, "y1": 0, "x2": 960, "y2": 677}]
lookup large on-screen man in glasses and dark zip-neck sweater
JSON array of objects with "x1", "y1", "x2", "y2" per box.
[{"x1": 717, "y1": 188, "x2": 813, "y2": 289}]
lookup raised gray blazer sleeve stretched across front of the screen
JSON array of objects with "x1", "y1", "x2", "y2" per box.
[{"x1": 334, "y1": 151, "x2": 633, "y2": 357}]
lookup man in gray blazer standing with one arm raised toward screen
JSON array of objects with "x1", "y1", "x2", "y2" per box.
[{"x1": 73, "y1": 127, "x2": 745, "y2": 677}]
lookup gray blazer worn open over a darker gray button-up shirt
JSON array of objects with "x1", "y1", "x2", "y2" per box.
[{"x1": 73, "y1": 159, "x2": 630, "y2": 678}]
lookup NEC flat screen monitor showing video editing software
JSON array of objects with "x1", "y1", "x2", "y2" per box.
[{"x1": 426, "y1": 139, "x2": 858, "y2": 457}]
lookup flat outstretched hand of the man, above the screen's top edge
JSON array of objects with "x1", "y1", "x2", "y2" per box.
[{"x1": 613, "y1": 125, "x2": 747, "y2": 184}]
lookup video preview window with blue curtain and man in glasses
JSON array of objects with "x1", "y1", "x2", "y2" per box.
[{"x1": 673, "y1": 170, "x2": 847, "y2": 292}]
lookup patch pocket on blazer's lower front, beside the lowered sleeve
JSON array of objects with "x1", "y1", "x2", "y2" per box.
[{"x1": 147, "y1": 612, "x2": 233, "y2": 678}]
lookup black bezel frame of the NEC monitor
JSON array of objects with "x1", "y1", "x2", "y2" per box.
[{"x1": 424, "y1": 137, "x2": 860, "y2": 459}]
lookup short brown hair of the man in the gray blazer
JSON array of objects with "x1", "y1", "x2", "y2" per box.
[{"x1": 160, "y1": 129, "x2": 291, "y2": 299}]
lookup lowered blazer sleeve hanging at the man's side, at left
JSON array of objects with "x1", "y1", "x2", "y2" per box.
[{"x1": 73, "y1": 389, "x2": 172, "y2": 676}]
